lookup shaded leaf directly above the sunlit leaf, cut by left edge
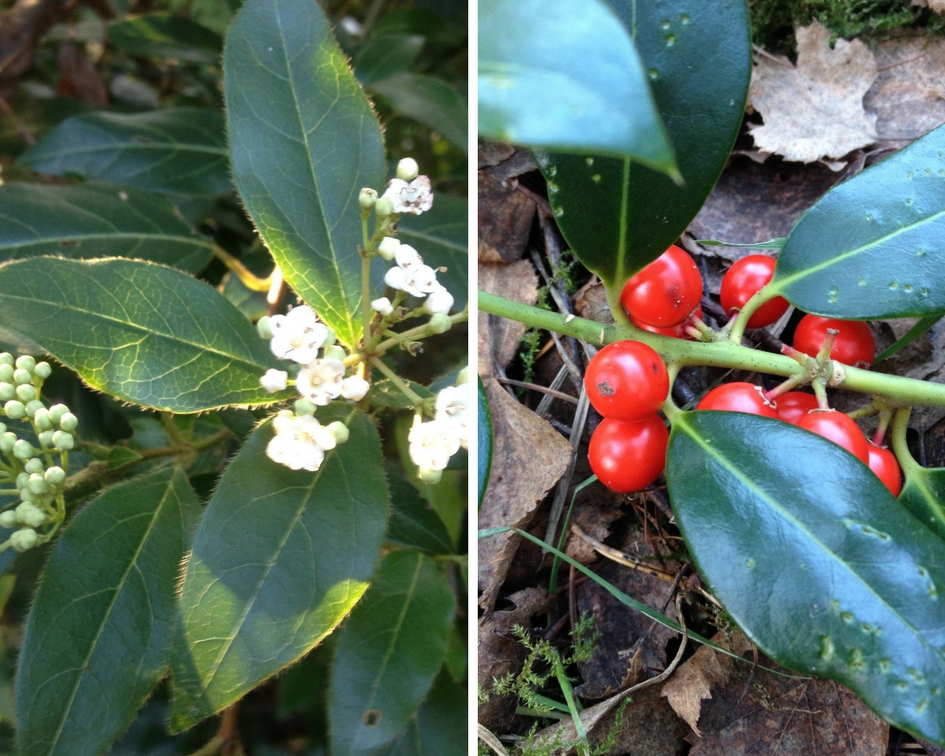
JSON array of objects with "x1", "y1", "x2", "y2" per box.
[{"x1": 0, "y1": 184, "x2": 213, "y2": 273}]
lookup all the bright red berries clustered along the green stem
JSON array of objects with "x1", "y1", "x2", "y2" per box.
[{"x1": 584, "y1": 246, "x2": 902, "y2": 496}]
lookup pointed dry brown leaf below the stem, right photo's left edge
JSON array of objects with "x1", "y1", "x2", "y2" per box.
[{"x1": 478, "y1": 378, "x2": 571, "y2": 614}]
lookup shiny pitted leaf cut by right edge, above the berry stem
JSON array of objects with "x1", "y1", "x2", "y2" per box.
[{"x1": 770, "y1": 126, "x2": 945, "y2": 320}]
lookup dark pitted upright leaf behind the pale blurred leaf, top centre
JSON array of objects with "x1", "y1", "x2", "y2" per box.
[{"x1": 536, "y1": 0, "x2": 751, "y2": 286}]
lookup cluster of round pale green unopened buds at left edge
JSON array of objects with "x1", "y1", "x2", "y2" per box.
[{"x1": 0, "y1": 352, "x2": 79, "y2": 551}]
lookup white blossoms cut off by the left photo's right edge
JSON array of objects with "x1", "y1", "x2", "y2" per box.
[{"x1": 408, "y1": 370, "x2": 469, "y2": 483}]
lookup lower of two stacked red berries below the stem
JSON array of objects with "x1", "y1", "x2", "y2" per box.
[{"x1": 587, "y1": 414, "x2": 669, "y2": 493}]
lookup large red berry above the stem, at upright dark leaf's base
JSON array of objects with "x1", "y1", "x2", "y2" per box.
[{"x1": 620, "y1": 246, "x2": 702, "y2": 328}]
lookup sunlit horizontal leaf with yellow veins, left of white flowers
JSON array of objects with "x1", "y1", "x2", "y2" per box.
[{"x1": 0, "y1": 257, "x2": 278, "y2": 412}]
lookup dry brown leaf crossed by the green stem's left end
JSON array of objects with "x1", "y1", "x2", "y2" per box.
[{"x1": 478, "y1": 260, "x2": 538, "y2": 378}]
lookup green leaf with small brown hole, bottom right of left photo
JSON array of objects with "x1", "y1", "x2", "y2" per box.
[{"x1": 328, "y1": 551, "x2": 456, "y2": 756}]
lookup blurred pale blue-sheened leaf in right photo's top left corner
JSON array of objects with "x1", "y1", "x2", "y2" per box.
[{"x1": 478, "y1": 0, "x2": 676, "y2": 171}]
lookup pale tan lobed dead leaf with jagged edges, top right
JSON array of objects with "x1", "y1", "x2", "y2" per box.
[{"x1": 749, "y1": 21, "x2": 877, "y2": 163}]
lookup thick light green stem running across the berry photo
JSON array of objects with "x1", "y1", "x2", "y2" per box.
[{"x1": 479, "y1": 291, "x2": 945, "y2": 407}]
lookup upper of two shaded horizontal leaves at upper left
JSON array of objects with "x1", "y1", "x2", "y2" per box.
[{"x1": 17, "y1": 108, "x2": 233, "y2": 196}]
